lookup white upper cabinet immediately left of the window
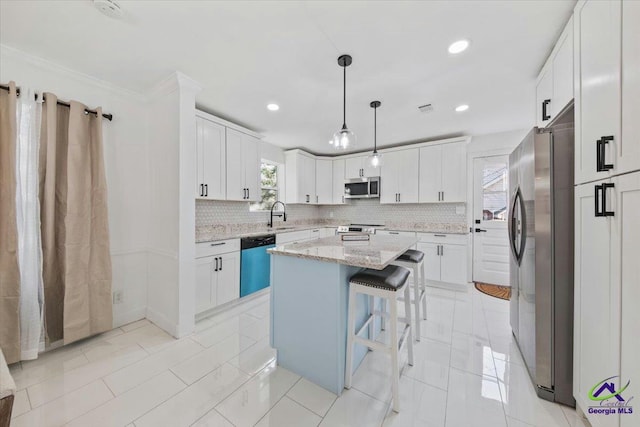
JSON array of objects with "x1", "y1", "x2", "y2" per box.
[{"x1": 226, "y1": 128, "x2": 260, "y2": 201}]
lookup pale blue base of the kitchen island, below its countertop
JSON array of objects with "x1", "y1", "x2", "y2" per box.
[{"x1": 270, "y1": 255, "x2": 368, "y2": 395}]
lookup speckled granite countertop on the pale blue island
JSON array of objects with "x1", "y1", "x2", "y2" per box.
[{"x1": 267, "y1": 235, "x2": 419, "y2": 270}]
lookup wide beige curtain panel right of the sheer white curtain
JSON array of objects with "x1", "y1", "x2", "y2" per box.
[{"x1": 40, "y1": 93, "x2": 113, "y2": 344}]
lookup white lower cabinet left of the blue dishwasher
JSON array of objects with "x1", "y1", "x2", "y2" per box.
[{"x1": 195, "y1": 239, "x2": 240, "y2": 314}]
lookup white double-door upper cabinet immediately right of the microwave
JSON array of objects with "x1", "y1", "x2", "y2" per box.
[{"x1": 380, "y1": 148, "x2": 419, "y2": 203}]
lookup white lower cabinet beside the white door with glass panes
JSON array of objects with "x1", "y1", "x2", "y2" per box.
[{"x1": 417, "y1": 233, "x2": 468, "y2": 285}]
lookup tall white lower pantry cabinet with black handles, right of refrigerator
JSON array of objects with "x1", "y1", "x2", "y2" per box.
[{"x1": 573, "y1": 172, "x2": 640, "y2": 427}]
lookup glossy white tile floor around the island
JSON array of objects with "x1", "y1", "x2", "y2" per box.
[{"x1": 11, "y1": 288, "x2": 586, "y2": 427}]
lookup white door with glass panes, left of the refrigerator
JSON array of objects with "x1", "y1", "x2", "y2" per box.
[{"x1": 473, "y1": 156, "x2": 509, "y2": 285}]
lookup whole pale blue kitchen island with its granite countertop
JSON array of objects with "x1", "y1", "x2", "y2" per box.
[{"x1": 267, "y1": 235, "x2": 418, "y2": 395}]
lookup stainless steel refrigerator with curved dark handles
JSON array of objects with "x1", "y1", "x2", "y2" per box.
[{"x1": 508, "y1": 104, "x2": 575, "y2": 406}]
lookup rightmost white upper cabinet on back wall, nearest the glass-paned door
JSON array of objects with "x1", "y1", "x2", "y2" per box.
[{"x1": 419, "y1": 142, "x2": 467, "y2": 203}]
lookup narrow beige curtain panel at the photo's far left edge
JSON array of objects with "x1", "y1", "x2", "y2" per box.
[{"x1": 0, "y1": 82, "x2": 20, "y2": 363}]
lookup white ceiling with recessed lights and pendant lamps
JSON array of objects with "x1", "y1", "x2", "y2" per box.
[{"x1": 0, "y1": 0, "x2": 575, "y2": 154}]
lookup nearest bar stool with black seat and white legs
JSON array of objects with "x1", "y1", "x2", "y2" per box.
[{"x1": 344, "y1": 265, "x2": 413, "y2": 412}]
